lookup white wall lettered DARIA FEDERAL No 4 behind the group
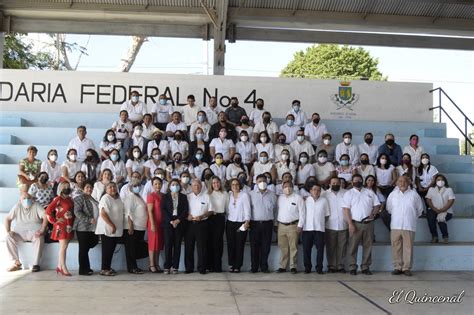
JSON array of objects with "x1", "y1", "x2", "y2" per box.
[{"x1": 0, "y1": 70, "x2": 433, "y2": 122}]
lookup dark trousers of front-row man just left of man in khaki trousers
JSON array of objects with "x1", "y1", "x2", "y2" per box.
[{"x1": 249, "y1": 220, "x2": 273, "y2": 271}]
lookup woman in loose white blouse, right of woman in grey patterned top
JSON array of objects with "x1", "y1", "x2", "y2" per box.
[{"x1": 95, "y1": 182, "x2": 125, "y2": 276}]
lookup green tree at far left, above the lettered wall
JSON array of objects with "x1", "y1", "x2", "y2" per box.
[{"x1": 3, "y1": 33, "x2": 55, "y2": 69}]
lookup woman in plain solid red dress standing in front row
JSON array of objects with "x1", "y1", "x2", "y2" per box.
[{"x1": 146, "y1": 177, "x2": 163, "y2": 273}]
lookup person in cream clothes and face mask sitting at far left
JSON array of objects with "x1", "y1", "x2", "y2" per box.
[{"x1": 5, "y1": 192, "x2": 48, "y2": 272}]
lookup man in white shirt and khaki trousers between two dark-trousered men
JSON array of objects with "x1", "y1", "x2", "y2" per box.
[{"x1": 277, "y1": 182, "x2": 304, "y2": 274}]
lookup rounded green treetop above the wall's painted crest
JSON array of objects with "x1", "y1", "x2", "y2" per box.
[{"x1": 280, "y1": 44, "x2": 387, "y2": 80}]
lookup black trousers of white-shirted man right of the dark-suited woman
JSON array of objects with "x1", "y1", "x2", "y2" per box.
[{"x1": 184, "y1": 220, "x2": 208, "y2": 272}]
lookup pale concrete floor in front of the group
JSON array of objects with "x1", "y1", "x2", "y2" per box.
[{"x1": 0, "y1": 270, "x2": 474, "y2": 315}]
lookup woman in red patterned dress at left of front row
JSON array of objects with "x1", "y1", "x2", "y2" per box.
[{"x1": 46, "y1": 182, "x2": 74, "y2": 276}]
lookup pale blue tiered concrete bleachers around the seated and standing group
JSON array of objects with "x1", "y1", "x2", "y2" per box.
[{"x1": 0, "y1": 108, "x2": 474, "y2": 270}]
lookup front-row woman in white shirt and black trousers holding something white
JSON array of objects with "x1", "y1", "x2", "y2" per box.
[{"x1": 226, "y1": 178, "x2": 251, "y2": 273}]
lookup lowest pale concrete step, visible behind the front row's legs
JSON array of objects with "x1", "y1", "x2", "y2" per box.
[{"x1": 0, "y1": 241, "x2": 474, "y2": 273}]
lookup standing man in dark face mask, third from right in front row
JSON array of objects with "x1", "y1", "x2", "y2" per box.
[{"x1": 322, "y1": 177, "x2": 349, "y2": 273}]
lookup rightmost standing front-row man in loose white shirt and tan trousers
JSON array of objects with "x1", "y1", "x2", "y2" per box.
[{"x1": 387, "y1": 176, "x2": 423, "y2": 276}]
